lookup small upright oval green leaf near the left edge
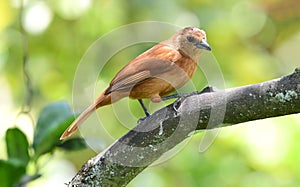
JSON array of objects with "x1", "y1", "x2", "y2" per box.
[{"x1": 5, "y1": 128, "x2": 30, "y2": 166}]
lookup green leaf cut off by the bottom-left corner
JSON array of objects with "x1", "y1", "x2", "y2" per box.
[{"x1": 0, "y1": 160, "x2": 26, "y2": 187}]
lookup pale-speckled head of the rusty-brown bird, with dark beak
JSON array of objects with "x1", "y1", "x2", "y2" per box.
[{"x1": 172, "y1": 27, "x2": 211, "y2": 60}]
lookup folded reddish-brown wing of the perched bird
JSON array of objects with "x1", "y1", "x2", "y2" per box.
[{"x1": 105, "y1": 46, "x2": 181, "y2": 94}]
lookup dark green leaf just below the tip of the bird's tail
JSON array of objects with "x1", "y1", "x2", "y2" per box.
[{"x1": 57, "y1": 137, "x2": 87, "y2": 151}]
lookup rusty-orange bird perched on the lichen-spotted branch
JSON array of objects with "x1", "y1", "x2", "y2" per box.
[{"x1": 60, "y1": 27, "x2": 211, "y2": 140}]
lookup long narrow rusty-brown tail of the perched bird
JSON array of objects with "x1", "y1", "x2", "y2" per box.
[{"x1": 60, "y1": 94, "x2": 107, "y2": 140}]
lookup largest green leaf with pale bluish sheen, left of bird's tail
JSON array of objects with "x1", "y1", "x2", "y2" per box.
[{"x1": 33, "y1": 102, "x2": 75, "y2": 160}]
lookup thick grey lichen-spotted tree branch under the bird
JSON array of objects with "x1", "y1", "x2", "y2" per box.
[{"x1": 69, "y1": 68, "x2": 300, "y2": 187}]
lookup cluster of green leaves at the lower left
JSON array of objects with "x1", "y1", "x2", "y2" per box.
[{"x1": 0, "y1": 102, "x2": 86, "y2": 187}]
